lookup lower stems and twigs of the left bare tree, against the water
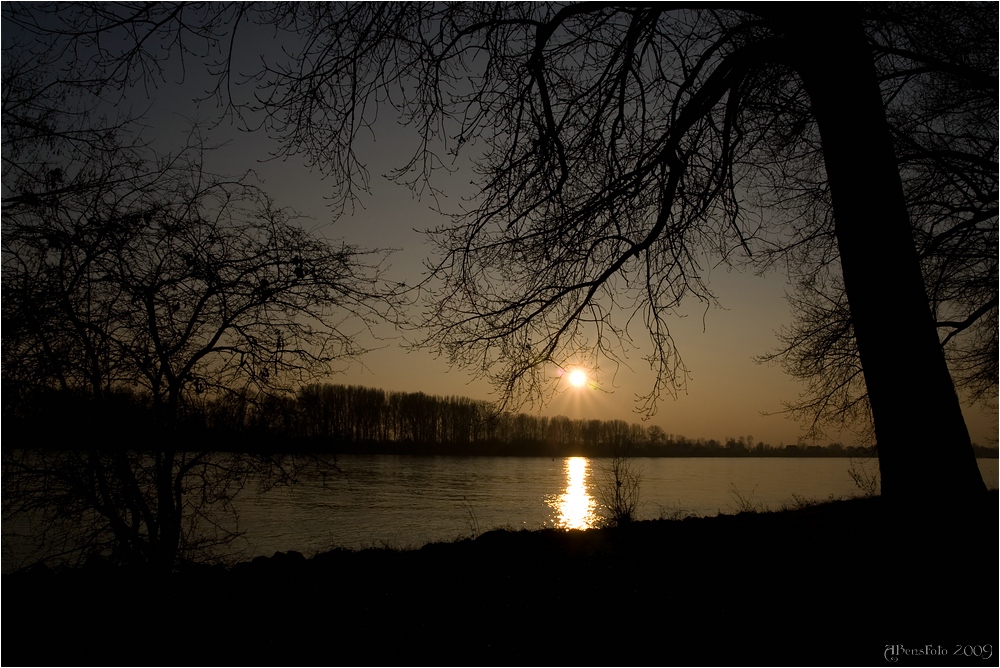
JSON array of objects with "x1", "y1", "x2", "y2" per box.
[{"x1": 3, "y1": 448, "x2": 312, "y2": 571}]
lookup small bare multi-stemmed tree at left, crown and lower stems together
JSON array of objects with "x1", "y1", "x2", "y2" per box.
[{"x1": 3, "y1": 138, "x2": 385, "y2": 568}]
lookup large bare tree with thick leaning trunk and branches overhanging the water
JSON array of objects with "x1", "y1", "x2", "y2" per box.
[{"x1": 267, "y1": 5, "x2": 984, "y2": 502}]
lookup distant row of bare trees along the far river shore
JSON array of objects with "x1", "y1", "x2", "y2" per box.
[{"x1": 11, "y1": 384, "x2": 997, "y2": 457}]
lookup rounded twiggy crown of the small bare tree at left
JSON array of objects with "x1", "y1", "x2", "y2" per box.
[{"x1": 4, "y1": 151, "x2": 390, "y2": 425}]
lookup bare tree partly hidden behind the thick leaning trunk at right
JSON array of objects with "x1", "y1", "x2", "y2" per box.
[{"x1": 763, "y1": 5, "x2": 997, "y2": 440}]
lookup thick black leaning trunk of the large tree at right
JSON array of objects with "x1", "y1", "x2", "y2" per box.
[{"x1": 786, "y1": 5, "x2": 986, "y2": 507}]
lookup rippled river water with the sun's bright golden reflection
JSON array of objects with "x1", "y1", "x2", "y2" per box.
[{"x1": 3, "y1": 455, "x2": 998, "y2": 572}]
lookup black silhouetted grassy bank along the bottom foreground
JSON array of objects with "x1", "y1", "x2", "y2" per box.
[{"x1": 2, "y1": 493, "x2": 998, "y2": 666}]
